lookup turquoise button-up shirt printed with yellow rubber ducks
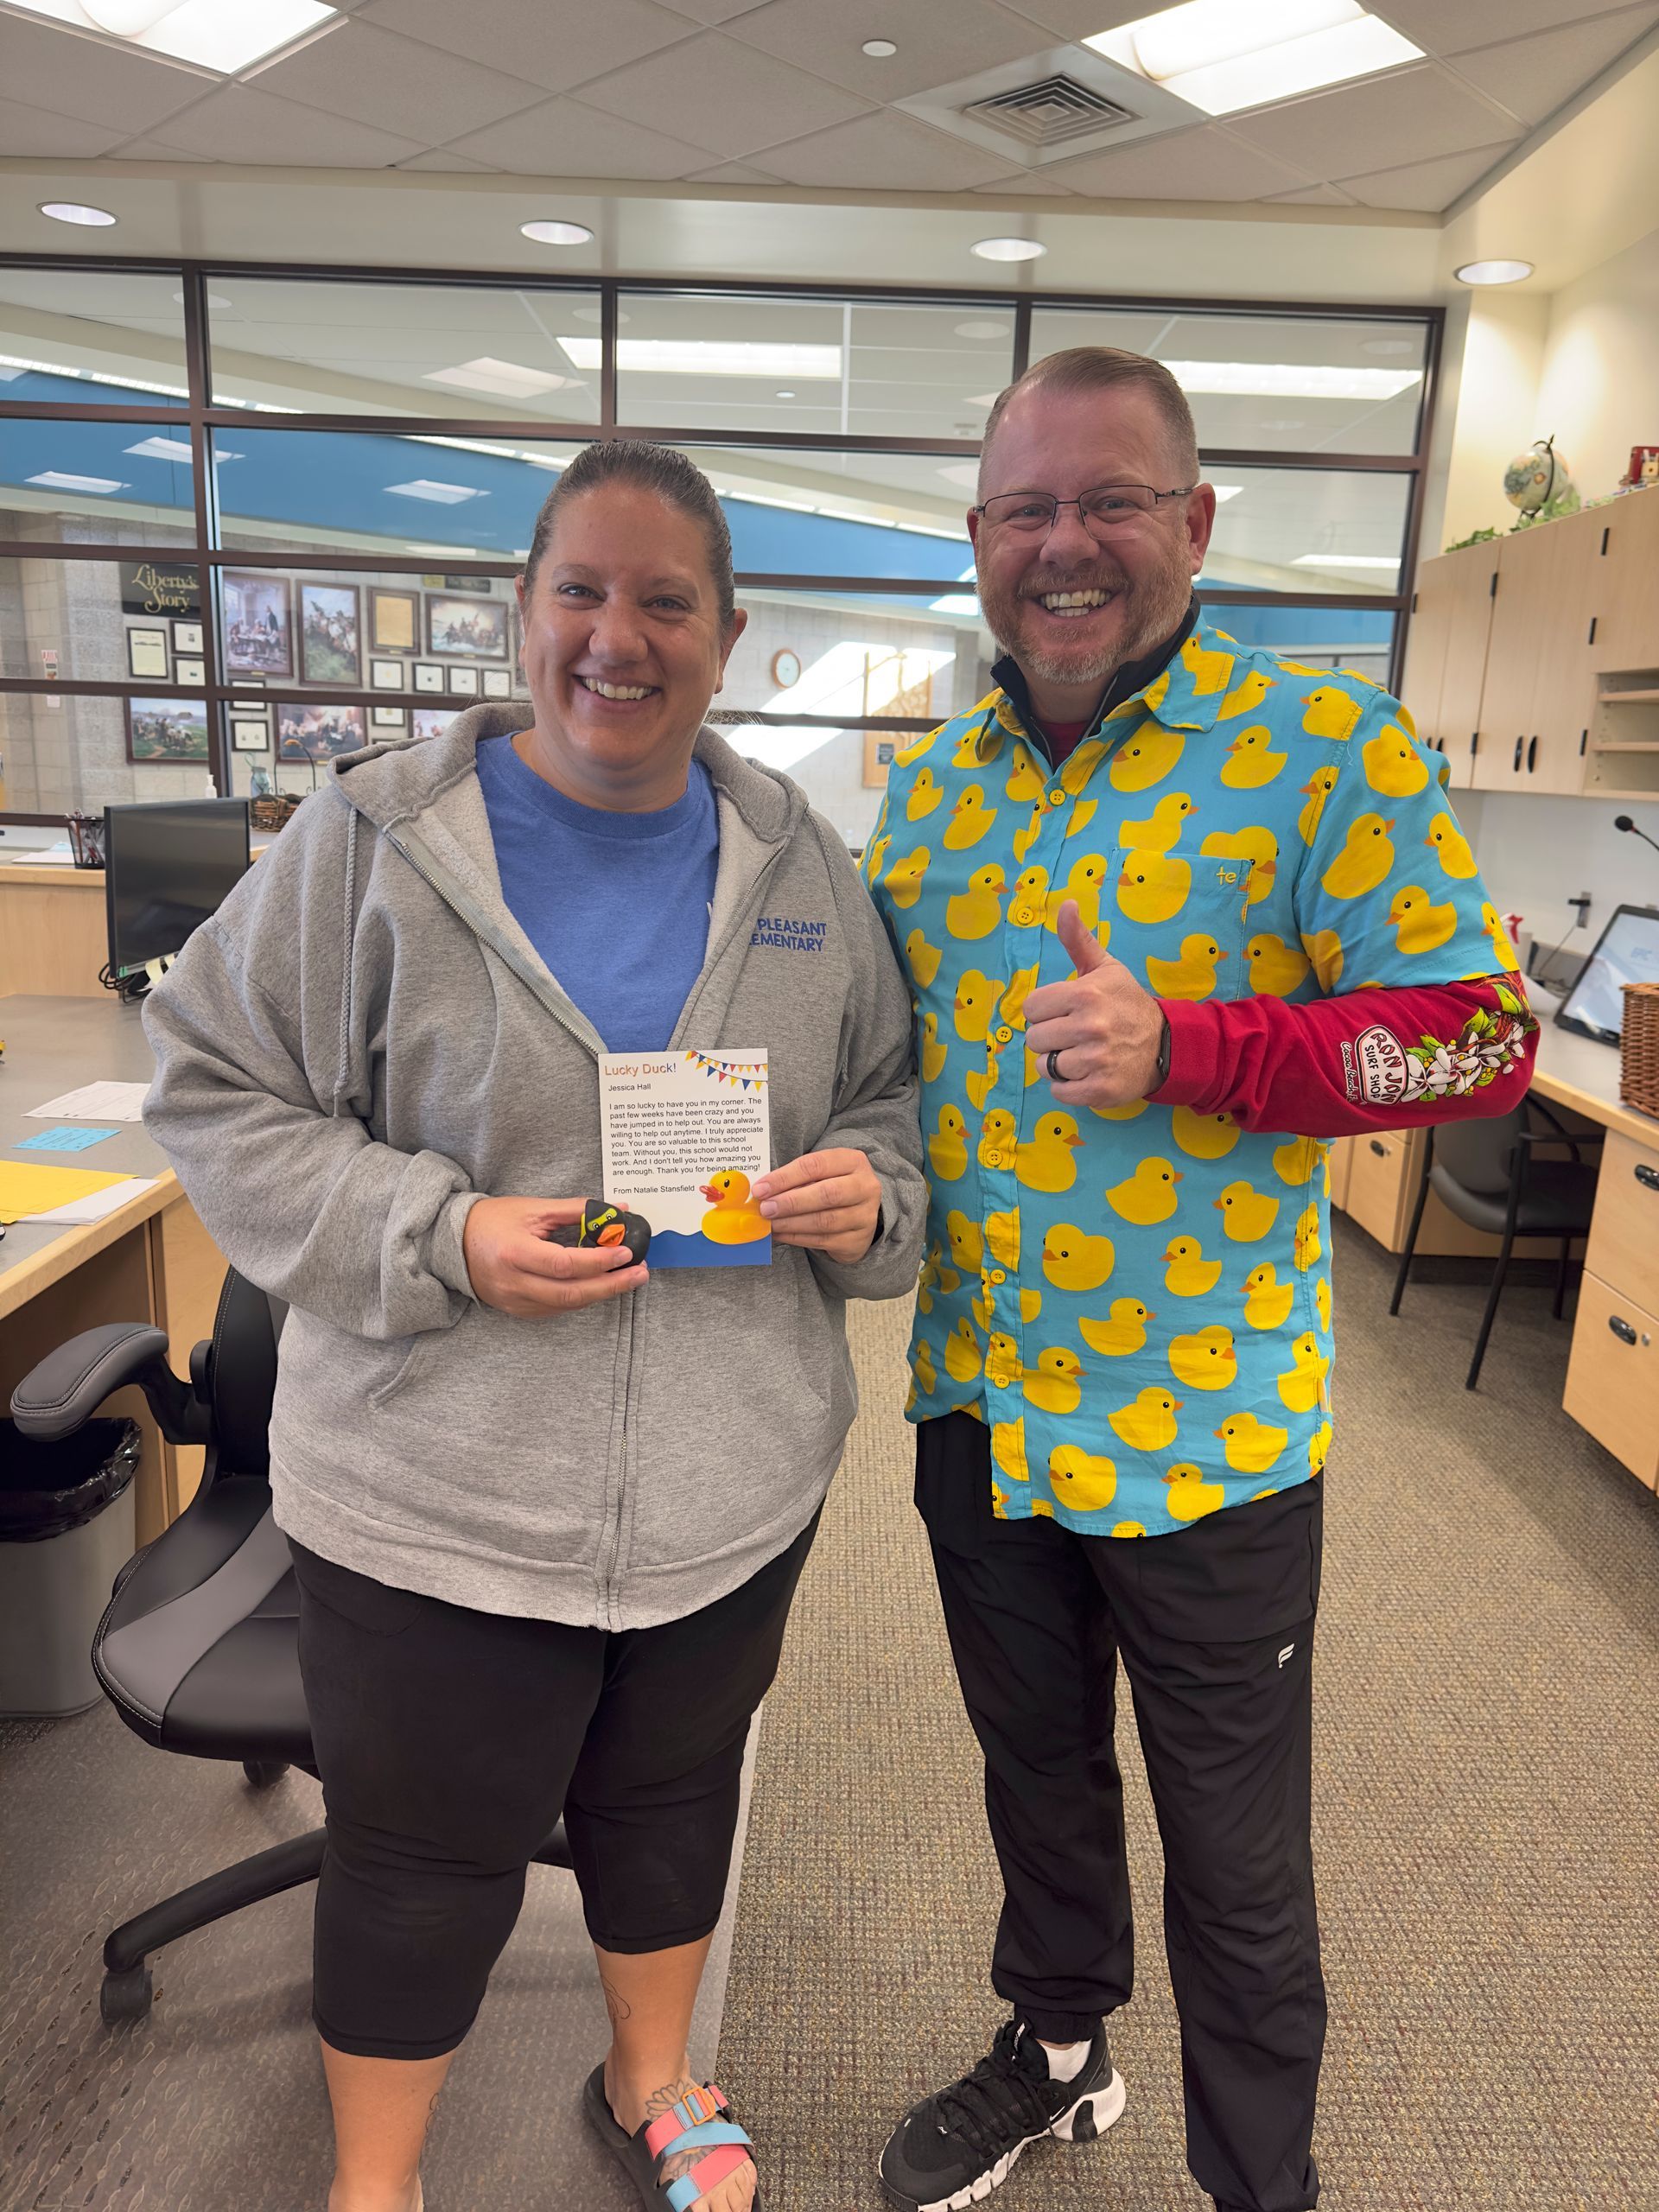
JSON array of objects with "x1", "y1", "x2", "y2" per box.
[{"x1": 865, "y1": 620, "x2": 1516, "y2": 1537}]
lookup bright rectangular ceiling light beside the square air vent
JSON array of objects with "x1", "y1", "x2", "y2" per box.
[{"x1": 1084, "y1": 0, "x2": 1422, "y2": 115}]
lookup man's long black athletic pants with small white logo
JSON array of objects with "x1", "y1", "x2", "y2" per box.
[{"x1": 916, "y1": 1414, "x2": 1325, "y2": 2212}]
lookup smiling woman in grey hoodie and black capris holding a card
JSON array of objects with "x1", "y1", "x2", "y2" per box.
[{"x1": 146, "y1": 445, "x2": 925, "y2": 2212}]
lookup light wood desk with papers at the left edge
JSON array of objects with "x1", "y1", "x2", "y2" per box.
[{"x1": 0, "y1": 1000, "x2": 226, "y2": 1544}]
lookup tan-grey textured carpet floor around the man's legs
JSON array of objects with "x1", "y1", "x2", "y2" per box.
[{"x1": 719, "y1": 1224, "x2": 1659, "y2": 2212}]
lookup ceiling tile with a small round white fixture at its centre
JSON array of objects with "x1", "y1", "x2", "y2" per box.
[{"x1": 730, "y1": 0, "x2": 1048, "y2": 99}]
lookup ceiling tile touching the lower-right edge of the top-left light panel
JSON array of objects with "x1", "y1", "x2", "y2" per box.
[{"x1": 254, "y1": 20, "x2": 537, "y2": 146}]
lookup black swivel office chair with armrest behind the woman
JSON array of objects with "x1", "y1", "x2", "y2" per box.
[{"x1": 11, "y1": 1268, "x2": 570, "y2": 2024}]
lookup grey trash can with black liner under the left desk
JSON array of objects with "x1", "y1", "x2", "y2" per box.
[{"x1": 0, "y1": 1421, "x2": 139, "y2": 1721}]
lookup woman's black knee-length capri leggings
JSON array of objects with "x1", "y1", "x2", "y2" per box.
[{"x1": 292, "y1": 1517, "x2": 818, "y2": 2059}]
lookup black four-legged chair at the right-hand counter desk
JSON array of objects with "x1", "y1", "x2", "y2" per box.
[{"x1": 1389, "y1": 1097, "x2": 1604, "y2": 1389}]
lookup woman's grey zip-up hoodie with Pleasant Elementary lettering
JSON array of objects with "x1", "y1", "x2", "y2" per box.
[{"x1": 143, "y1": 706, "x2": 927, "y2": 1628}]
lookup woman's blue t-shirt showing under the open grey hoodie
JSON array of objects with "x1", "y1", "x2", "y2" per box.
[{"x1": 478, "y1": 736, "x2": 721, "y2": 1053}]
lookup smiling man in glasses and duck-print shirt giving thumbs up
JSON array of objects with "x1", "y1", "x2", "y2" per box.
[{"x1": 865, "y1": 347, "x2": 1535, "y2": 2212}]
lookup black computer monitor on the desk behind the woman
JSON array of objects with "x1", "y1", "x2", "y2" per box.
[{"x1": 104, "y1": 798, "x2": 248, "y2": 982}]
